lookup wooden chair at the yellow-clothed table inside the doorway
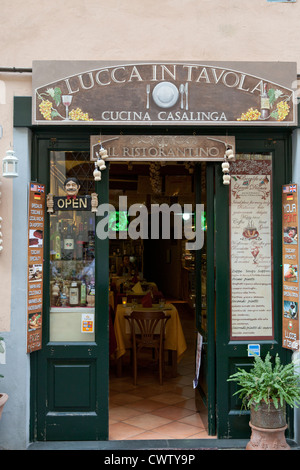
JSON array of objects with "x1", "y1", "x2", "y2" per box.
[{"x1": 125, "y1": 310, "x2": 171, "y2": 385}]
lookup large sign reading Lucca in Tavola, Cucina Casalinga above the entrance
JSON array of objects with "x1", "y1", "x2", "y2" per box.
[{"x1": 32, "y1": 61, "x2": 297, "y2": 126}]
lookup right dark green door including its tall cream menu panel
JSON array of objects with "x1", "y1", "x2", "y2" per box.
[{"x1": 215, "y1": 139, "x2": 291, "y2": 439}]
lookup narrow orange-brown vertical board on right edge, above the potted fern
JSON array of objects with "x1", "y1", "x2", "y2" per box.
[{"x1": 282, "y1": 184, "x2": 299, "y2": 350}]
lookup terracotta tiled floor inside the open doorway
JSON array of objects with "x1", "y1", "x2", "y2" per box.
[{"x1": 109, "y1": 302, "x2": 217, "y2": 440}]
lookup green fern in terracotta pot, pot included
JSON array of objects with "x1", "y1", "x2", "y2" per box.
[{"x1": 228, "y1": 352, "x2": 300, "y2": 450}]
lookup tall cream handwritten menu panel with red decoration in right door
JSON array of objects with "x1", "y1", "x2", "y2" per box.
[{"x1": 230, "y1": 155, "x2": 273, "y2": 340}]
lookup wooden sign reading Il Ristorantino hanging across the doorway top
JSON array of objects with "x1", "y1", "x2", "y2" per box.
[{"x1": 90, "y1": 135, "x2": 235, "y2": 162}]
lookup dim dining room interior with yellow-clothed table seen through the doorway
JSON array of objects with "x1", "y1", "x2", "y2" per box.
[{"x1": 109, "y1": 162, "x2": 215, "y2": 440}]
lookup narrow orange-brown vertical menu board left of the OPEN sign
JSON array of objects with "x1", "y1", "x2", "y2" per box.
[{"x1": 27, "y1": 183, "x2": 45, "y2": 353}]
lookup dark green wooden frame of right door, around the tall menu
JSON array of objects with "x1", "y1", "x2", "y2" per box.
[{"x1": 215, "y1": 135, "x2": 291, "y2": 439}]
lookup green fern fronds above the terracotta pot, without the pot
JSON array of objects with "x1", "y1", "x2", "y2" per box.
[{"x1": 227, "y1": 352, "x2": 300, "y2": 409}]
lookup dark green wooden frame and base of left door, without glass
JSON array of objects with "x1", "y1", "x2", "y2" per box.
[{"x1": 30, "y1": 133, "x2": 109, "y2": 440}]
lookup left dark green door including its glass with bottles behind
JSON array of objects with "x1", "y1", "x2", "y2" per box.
[{"x1": 31, "y1": 139, "x2": 108, "y2": 441}]
